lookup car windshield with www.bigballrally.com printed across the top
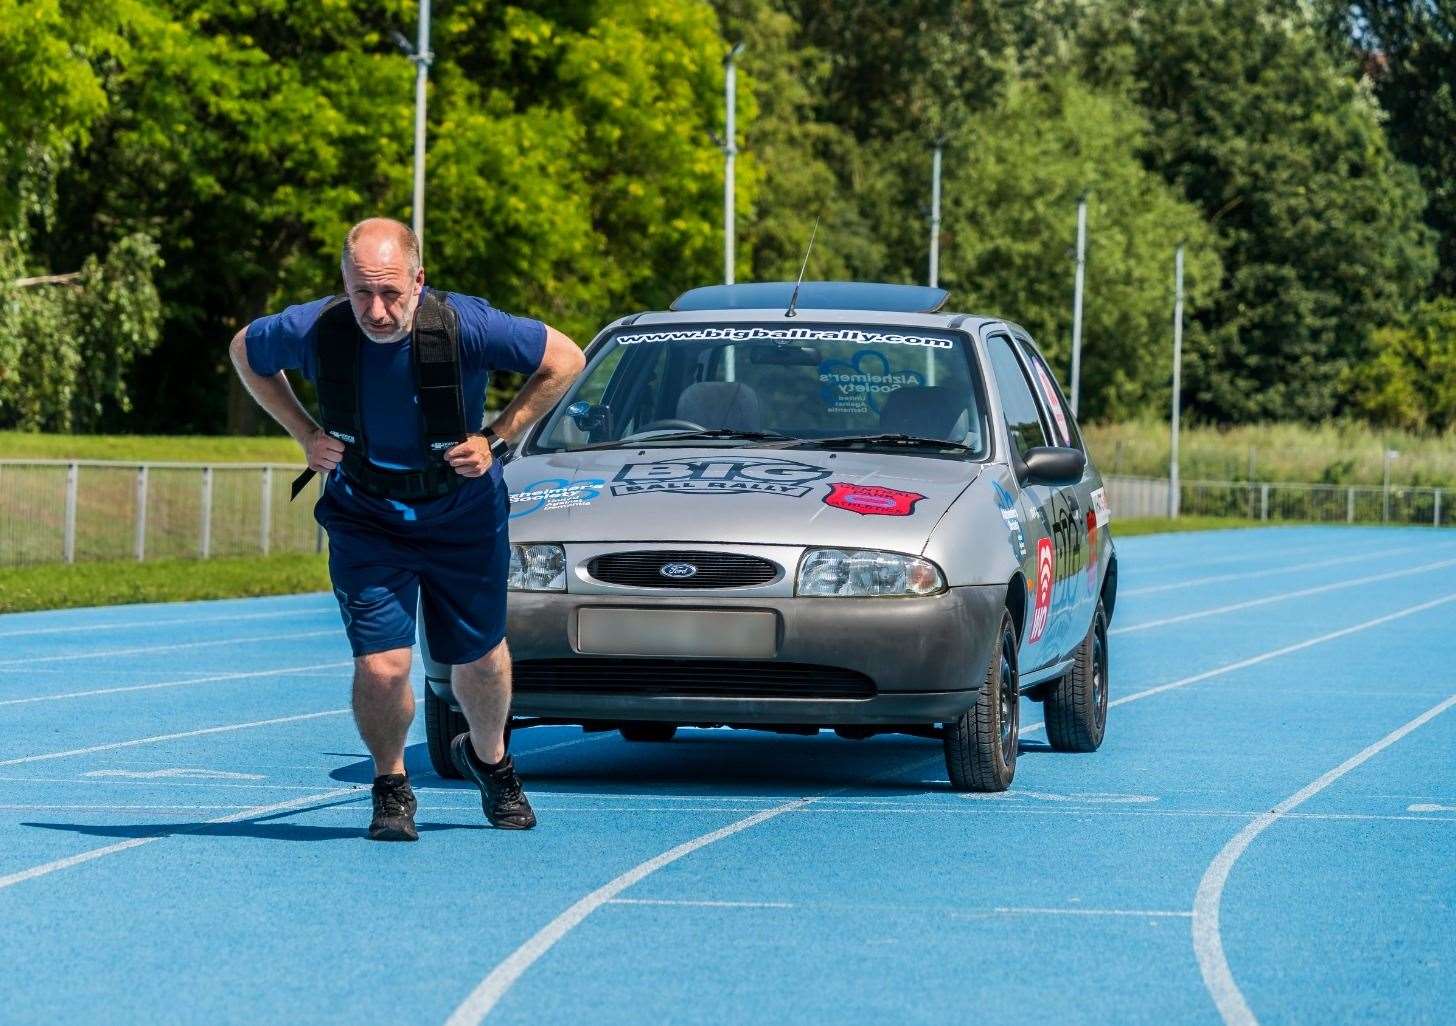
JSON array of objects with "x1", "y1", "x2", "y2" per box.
[{"x1": 533, "y1": 323, "x2": 987, "y2": 458}]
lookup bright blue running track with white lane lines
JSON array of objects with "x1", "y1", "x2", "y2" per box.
[{"x1": 0, "y1": 527, "x2": 1456, "y2": 1026}]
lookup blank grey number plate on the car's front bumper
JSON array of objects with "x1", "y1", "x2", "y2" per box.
[{"x1": 577, "y1": 607, "x2": 778, "y2": 659}]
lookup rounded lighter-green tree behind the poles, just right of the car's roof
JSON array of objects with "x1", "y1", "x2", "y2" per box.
[{"x1": 941, "y1": 76, "x2": 1220, "y2": 419}]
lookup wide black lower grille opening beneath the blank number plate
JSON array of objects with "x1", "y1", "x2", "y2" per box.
[{"x1": 511, "y1": 656, "x2": 875, "y2": 699}]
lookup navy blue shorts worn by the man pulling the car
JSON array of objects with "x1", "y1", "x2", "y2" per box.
[{"x1": 313, "y1": 485, "x2": 511, "y2": 665}]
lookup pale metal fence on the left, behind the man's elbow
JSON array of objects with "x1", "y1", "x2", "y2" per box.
[{"x1": 0, "y1": 460, "x2": 323, "y2": 566}]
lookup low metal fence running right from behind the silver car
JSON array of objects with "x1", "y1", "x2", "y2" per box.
[{"x1": 1107, "y1": 477, "x2": 1450, "y2": 527}]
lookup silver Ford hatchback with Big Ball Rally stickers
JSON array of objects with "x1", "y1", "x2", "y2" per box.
[{"x1": 421, "y1": 282, "x2": 1117, "y2": 790}]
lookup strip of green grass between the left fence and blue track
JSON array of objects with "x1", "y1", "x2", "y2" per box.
[{"x1": 0, "y1": 553, "x2": 329, "y2": 613}]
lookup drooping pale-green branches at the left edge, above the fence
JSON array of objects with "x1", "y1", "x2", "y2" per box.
[{"x1": 0, "y1": 234, "x2": 160, "y2": 431}]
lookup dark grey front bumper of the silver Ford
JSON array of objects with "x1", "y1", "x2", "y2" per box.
[{"x1": 425, "y1": 585, "x2": 1006, "y2": 726}]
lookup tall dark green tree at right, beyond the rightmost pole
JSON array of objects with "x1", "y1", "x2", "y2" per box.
[{"x1": 1082, "y1": 0, "x2": 1434, "y2": 422}]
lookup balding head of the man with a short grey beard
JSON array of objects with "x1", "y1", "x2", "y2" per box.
[{"x1": 341, "y1": 217, "x2": 425, "y2": 342}]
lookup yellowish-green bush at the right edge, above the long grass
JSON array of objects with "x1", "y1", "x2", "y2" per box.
[{"x1": 1345, "y1": 298, "x2": 1456, "y2": 432}]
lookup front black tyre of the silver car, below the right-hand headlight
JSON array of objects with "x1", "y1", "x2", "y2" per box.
[{"x1": 943, "y1": 613, "x2": 1021, "y2": 792}]
